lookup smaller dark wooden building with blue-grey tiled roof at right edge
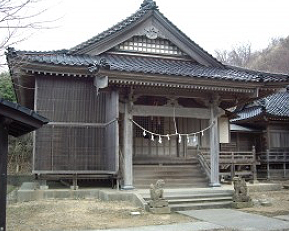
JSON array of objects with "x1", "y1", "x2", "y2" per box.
[{"x1": 231, "y1": 89, "x2": 289, "y2": 178}]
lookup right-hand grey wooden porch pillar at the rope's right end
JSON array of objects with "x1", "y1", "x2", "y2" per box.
[{"x1": 210, "y1": 102, "x2": 221, "y2": 187}]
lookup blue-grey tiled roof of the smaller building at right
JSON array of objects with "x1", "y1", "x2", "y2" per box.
[{"x1": 231, "y1": 91, "x2": 289, "y2": 122}]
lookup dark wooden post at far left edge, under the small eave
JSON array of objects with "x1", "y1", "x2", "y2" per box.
[{"x1": 0, "y1": 122, "x2": 8, "y2": 231}]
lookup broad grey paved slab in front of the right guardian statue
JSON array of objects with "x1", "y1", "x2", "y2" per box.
[{"x1": 179, "y1": 209, "x2": 289, "y2": 231}]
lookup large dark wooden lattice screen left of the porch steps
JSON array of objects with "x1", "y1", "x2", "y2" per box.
[{"x1": 33, "y1": 76, "x2": 118, "y2": 174}]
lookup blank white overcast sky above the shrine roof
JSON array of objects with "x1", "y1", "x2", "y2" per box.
[{"x1": 8, "y1": 0, "x2": 289, "y2": 54}]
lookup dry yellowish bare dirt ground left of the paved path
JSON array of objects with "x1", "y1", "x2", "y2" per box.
[{"x1": 7, "y1": 200, "x2": 196, "y2": 231}]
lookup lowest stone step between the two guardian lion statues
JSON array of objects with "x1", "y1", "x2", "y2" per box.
[{"x1": 169, "y1": 201, "x2": 232, "y2": 211}]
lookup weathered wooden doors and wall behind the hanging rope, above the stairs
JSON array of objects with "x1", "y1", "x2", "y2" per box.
[{"x1": 133, "y1": 117, "x2": 210, "y2": 157}]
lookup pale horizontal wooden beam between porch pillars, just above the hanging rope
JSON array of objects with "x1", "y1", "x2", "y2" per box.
[{"x1": 132, "y1": 105, "x2": 210, "y2": 119}]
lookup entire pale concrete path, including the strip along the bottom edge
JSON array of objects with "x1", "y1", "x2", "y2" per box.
[{"x1": 81, "y1": 209, "x2": 289, "y2": 231}]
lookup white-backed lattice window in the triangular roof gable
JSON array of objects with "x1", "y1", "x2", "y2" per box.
[{"x1": 115, "y1": 36, "x2": 186, "y2": 56}]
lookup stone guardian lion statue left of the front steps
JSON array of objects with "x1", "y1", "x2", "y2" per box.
[{"x1": 148, "y1": 180, "x2": 171, "y2": 213}]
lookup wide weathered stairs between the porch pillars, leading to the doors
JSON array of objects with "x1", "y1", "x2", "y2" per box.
[{"x1": 133, "y1": 158, "x2": 208, "y2": 189}]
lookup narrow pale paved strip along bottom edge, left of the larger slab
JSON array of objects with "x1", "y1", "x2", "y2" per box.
[{"x1": 82, "y1": 222, "x2": 224, "y2": 231}]
